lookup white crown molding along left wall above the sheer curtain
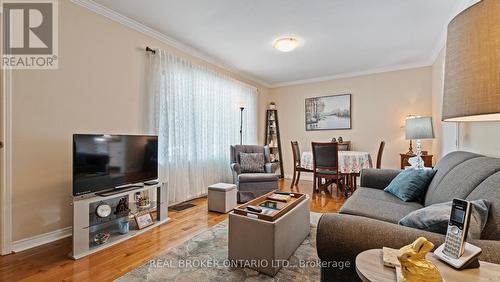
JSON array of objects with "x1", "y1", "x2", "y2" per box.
[{"x1": 71, "y1": 0, "x2": 271, "y2": 88}]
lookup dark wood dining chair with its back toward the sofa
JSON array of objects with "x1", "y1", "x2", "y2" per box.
[{"x1": 311, "y1": 142, "x2": 346, "y2": 195}]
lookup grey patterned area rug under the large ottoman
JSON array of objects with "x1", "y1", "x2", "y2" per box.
[{"x1": 116, "y1": 213, "x2": 320, "y2": 282}]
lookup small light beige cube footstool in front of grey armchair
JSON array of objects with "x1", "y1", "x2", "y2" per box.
[{"x1": 208, "y1": 183, "x2": 237, "y2": 213}]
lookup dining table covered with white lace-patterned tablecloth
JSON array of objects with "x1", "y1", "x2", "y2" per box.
[{"x1": 300, "y1": 151, "x2": 373, "y2": 194}]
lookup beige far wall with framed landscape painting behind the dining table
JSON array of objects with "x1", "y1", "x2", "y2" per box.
[{"x1": 269, "y1": 67, "x2": 432, "y2": 175}]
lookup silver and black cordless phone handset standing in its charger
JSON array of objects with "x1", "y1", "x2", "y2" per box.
[{"x1": 443, "y1": 199, "x2": 471, "y2": 258}]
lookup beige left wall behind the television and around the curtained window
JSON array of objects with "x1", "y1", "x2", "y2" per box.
[{"x1": 6, "y1": 1, "x2": 267, "y2": 241}]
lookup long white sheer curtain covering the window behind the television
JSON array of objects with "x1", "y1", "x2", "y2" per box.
[{"x1": 147, "y1": 50, "x2": 257, "y2": 203}]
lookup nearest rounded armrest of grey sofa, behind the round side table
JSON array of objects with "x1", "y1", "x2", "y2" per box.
[{"x1": 316, "y1": 214, "x2": 500, "y2": 281}]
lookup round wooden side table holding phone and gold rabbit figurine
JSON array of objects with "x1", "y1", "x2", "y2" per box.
[{"x1": 356, "y1": 249, "x2": 500, "y2": 282}]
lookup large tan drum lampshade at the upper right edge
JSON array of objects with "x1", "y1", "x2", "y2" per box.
[{"x1": 443, "y1": 0, "x2": 500, "y2": 121}]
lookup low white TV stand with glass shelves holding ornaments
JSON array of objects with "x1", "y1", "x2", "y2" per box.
[{"x1": 70, "y1": 182, "x2": 169, "y2": 259}]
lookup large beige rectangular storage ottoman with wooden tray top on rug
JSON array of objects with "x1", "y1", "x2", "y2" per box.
[{"x1": 228, "y1": 193, "x2": 311, "y2": 276}]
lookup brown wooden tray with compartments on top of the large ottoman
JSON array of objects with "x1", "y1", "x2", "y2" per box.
[{"x1": 233, "y1": 190, "x2": 307, "y2": 221}]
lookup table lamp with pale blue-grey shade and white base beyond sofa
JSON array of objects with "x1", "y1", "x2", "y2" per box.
[{"x1": 406, "y1": 117, "x2": 434, "y2": 169}]
